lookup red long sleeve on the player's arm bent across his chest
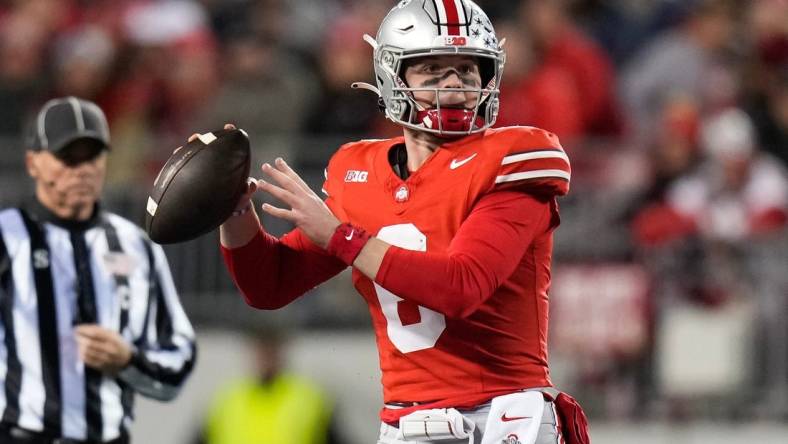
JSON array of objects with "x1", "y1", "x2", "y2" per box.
[{"x1": 375, "y1": 191, "x2": 552, "y2": 318}]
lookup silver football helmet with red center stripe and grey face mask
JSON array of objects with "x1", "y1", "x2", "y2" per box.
[{"x1": 353, "y1": 0, "x2": 505, "y2": 136}]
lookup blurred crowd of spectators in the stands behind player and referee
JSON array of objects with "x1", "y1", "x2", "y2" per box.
[{"x1": 0, "y1": 0, "x2": 788, "y2": 424}]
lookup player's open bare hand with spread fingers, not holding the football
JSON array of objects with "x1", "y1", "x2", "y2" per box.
[{"x1": 257, "y1": 158, "x2": 340, "y2": 248}]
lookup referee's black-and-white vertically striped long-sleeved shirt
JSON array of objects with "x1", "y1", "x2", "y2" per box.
[{"x1": 0, "y1": 202, "x2": 196, "y2": 442}]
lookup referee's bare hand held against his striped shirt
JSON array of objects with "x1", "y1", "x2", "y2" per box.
[{"x1": 74, "y1": 324, "x2": 131, "y2": 375}]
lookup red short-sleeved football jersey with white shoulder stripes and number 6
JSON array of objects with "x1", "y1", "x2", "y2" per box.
[{"x1": 323, "y1": 127, "x2": 570, "y2": 420}]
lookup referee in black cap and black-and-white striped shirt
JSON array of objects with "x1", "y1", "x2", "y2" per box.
[{"x1": 0, "y1": 97, "x2": 196, "y2": 444}]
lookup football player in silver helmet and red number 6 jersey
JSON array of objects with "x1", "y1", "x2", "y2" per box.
[{"x1": 220, "y1": 0, "x2": 588, "y2": 444}]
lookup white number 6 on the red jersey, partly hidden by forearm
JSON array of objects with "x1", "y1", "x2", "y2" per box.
[{"x1": 375, "y1": 224, "x2": 446, "y2": 353}]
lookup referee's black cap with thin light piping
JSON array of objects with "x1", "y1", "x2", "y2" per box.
[{"x1": 26, "y1": 96, "x2": 109, "y2": 154}]
